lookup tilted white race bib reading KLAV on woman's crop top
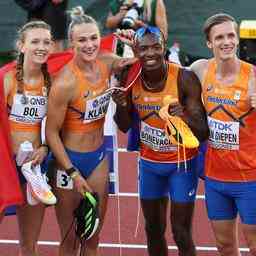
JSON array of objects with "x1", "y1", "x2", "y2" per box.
[{"x1": 84, "y1": 92, "x2": 112, "y2": 123}]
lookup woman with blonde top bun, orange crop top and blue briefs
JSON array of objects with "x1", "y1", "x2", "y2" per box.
[{"x1": 46, "y1": 7, "x2": 136, "y2": 256}]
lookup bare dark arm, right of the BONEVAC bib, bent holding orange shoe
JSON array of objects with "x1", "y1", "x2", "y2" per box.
[{"x1": 178, "y1": 69, "x2": 209, "y2": 142}]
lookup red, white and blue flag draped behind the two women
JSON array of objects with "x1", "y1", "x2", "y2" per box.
[{"x1": 0, "y1": 34, "x2": 117, "y2": 206}]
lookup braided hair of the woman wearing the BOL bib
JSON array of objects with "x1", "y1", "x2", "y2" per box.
[{"x1": 15, "y1": 20, "x2": 51, "y2": 94}]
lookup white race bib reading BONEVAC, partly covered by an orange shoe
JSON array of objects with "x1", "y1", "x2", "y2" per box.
[{"x1": 140, "y1": 122, "x2": 177, "y2": 152}]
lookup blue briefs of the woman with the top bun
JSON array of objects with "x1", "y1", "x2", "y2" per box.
[{"x1": 66, "y1": 143, "x2": 106, "y2": 178}]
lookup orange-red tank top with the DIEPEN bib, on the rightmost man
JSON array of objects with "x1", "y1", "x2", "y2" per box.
[{"x1": 202, "y1": 59, "x2": 256, "y2": 182}]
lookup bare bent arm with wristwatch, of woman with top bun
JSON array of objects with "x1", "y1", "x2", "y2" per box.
[{"x1": 45, "y1": 67, "x2": 75, "y2": 169}]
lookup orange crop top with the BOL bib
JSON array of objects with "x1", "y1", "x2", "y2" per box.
[{"x1": 6, "y1": 69, "x2": 47, "y2": 132}]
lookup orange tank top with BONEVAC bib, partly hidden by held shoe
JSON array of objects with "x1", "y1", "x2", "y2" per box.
[{"x1": 132, "y1": 63, "x2": 197, "y2": 163}]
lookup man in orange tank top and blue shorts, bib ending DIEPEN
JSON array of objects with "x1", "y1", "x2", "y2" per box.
[{"x1": 191, "y1": 13, "x2": 256, "y2": 256}]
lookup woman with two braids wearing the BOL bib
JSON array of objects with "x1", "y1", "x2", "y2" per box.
[{"x1": 3, "y1": 21, "x2": 52, "y2": 256}]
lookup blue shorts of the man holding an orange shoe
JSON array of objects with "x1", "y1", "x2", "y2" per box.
[{"x1": 139, "y1": 158, "x2": 198, "y2": 203}]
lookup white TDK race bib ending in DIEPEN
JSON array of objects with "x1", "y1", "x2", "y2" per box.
[{"x1": 208, "y1": 117, "x2": 239, "y2": 150}]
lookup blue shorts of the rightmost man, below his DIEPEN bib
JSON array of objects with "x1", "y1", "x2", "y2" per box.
[{"x1": 205, "y1": 178, "x2": 256, "y2": 225}]
